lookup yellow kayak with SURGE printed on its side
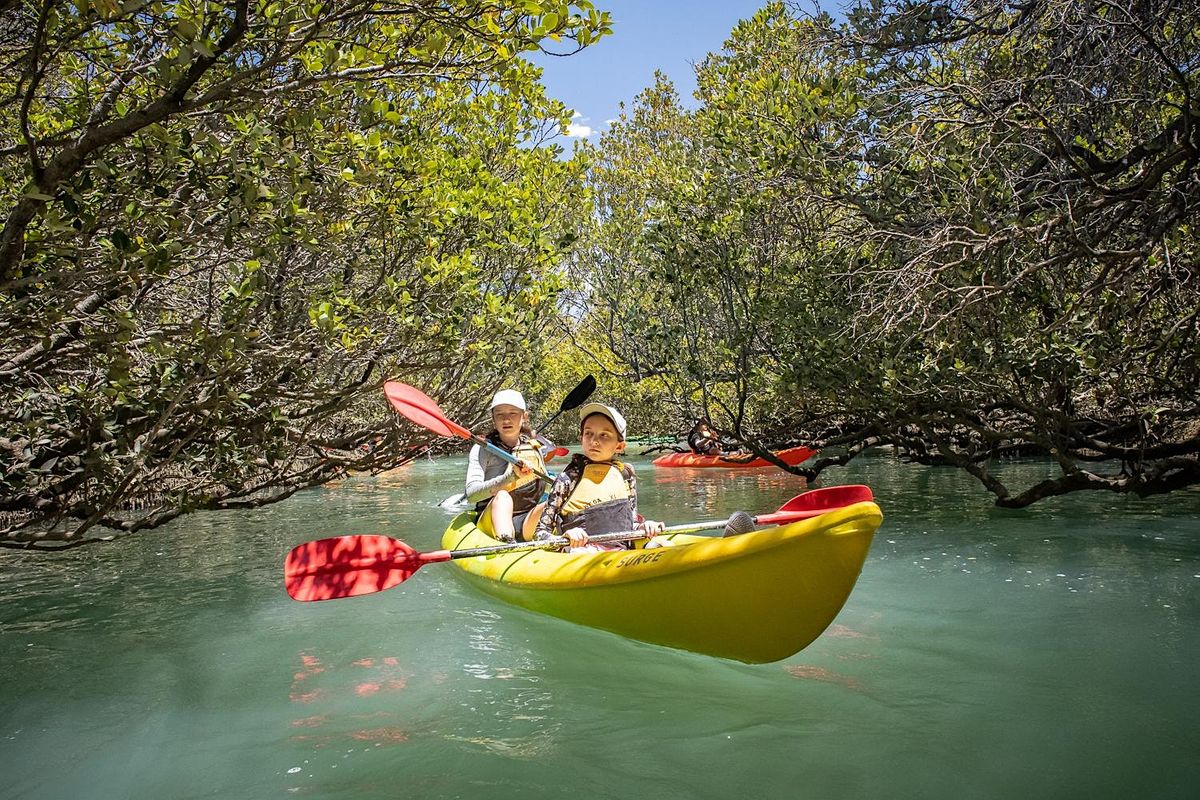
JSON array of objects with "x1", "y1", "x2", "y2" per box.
[{"x1": 442, "y1": 503, "x2": 883, "y2": 663}]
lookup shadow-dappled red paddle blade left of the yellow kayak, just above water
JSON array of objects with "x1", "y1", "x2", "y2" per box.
[{"x1": 283, "y1": 535, "x2": 426, "y2": 602}]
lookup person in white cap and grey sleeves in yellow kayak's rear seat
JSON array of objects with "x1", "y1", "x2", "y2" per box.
[{"x1": 466, "y1": 389, "x2": 546, "y2": 542}]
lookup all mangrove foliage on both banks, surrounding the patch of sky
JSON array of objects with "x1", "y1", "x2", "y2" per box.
[{"x1": 0, "y1": 0, "x2": 1200, "y2": 547}]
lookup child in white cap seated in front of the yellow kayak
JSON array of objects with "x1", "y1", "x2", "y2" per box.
[{"x1": 535, "y1": 403, "x2": 664, "y2": 553}]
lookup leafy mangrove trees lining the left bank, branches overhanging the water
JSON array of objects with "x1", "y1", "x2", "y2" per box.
[{"x1": 0, "y1": 0, "x2": 608, "y2": 546}]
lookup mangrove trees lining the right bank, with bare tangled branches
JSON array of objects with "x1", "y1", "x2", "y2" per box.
[{"x1": 572, "y1": 0, "x2": 1200, "y2": 506}]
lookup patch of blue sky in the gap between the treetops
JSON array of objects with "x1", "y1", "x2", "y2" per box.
[{"x1": 532, "y1": 0, "x2": 767, "y2": 137}]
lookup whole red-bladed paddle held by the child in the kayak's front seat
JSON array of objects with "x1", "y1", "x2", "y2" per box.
[{"x1": 283, "y1": 486, "x2": 871, "y2": 602}]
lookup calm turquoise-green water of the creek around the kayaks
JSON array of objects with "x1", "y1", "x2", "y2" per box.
[{"x1": 0, "y1": 455, "x2": 1200, "y2": 800}]
